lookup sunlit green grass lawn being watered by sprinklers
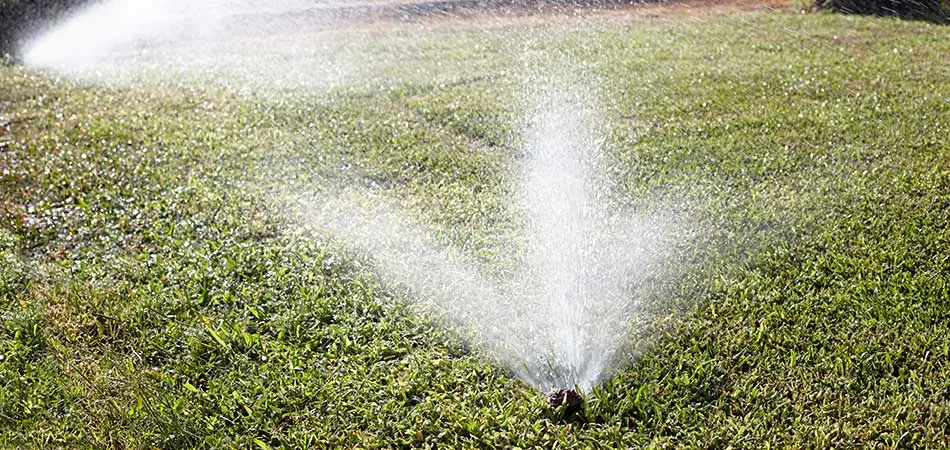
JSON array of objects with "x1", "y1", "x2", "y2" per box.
[{"x1": 0, "y1": 7, "x2": 950, "y2": 448}]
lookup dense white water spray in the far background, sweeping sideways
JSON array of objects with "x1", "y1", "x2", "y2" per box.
[{"x1": 21, "y1": 0, "x2": 373, "y2": 92}]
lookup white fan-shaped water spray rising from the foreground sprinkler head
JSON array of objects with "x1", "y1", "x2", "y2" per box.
[{"x1": 297, "y1": 82, "x2": 666, "y2": 391}]
